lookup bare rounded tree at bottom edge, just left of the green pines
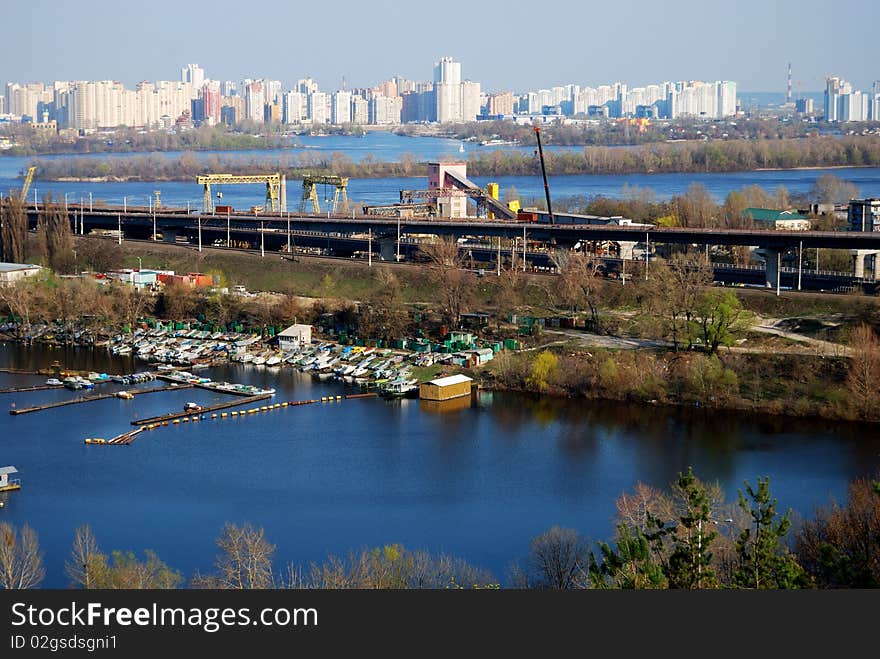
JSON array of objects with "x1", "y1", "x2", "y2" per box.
[{"x1": 512, "y1": 526, "x2": 590, "y2": 590}]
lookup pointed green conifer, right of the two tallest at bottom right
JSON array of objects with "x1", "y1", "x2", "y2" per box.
[{"x1": 733, "y1": 477, "x2": 807, "y2": 589}]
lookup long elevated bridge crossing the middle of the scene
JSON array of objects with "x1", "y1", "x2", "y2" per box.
[{"x1": 22, "y1": 205, "x2": 880, "y2": 288}]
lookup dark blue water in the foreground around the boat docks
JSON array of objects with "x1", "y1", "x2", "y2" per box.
[{"x1": 0, "y1": 343, "x2": 880, "y2": 588}]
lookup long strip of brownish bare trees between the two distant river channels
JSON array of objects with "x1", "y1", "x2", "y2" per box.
[{"x1": 25, "y1": 135, "x2": 880, "y2": 181}]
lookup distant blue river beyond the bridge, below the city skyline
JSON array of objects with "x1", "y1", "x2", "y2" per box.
[{"x1": 0, "y1": 131, "x2": 880, "y2": 211}]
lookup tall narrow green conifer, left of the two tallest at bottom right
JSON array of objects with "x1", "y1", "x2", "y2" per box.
[{"x1": 667, "y1": 467, "x2": 718, "y2": 588}]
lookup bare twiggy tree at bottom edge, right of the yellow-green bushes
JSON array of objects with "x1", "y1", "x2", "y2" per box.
[{"x1": 193, "y1": 522, "x2": 275, "y2": 590}]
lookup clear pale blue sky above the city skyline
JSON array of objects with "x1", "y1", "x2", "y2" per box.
[{"x1": 0, "y1": 0, "x2": 880, "y2": 92}]
